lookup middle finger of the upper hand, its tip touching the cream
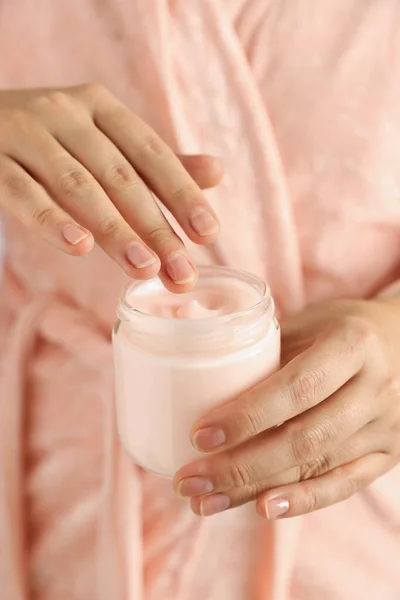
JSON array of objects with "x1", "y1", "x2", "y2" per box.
[{"x1": 56, "y1": 121, "x2": 196, "y2": 291}]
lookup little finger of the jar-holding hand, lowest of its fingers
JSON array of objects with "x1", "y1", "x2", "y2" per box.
[{"x1": 256, "y1": 453, "x2": 393, "y2": 519}]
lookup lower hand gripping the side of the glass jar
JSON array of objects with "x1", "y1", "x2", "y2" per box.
[{"x1": 174, "y1": 299, "x2": 400, "y2": 518}]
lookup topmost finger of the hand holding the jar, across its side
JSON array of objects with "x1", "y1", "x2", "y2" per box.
[{"x1": 191, "y1": 319, "x2": 365, "y2": 452}]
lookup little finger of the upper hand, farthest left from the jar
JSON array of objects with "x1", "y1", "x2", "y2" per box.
[{"x1": 0, "y1": 155, "x2": 94, "y2": 256}]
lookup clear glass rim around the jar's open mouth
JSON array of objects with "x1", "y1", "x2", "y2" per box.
[{"x1": 118, "y1": 265, "x2": 272, "y2": 329}]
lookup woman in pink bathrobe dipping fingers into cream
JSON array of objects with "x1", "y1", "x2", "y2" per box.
[{"x1": 0, "y1": 0, "x2": 400, "y2": 600}]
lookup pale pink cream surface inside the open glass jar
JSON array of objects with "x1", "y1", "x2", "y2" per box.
[{"x1": 128, "y1": 277, "x2": 260, "y2": 319}]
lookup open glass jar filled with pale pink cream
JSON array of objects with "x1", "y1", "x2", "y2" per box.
[{"x1": 113, "y1": 267, "x2": 280, "y2": 477}]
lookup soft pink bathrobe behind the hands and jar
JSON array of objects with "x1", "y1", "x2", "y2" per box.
[{"x1": 0, "y1": 0, "x2": 400, "y2": 600}]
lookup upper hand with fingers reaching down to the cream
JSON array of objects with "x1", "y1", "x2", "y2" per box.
[{"x1": 0, "y1": 85, "x2": 222, "y2": 292}]
